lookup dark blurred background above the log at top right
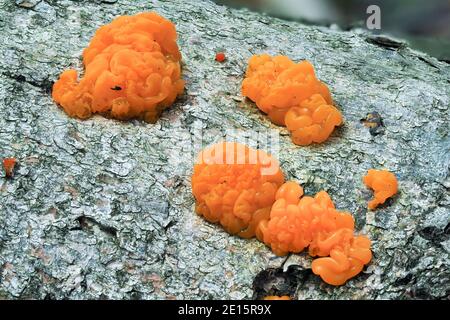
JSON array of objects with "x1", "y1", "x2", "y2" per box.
[{"x1": 214, "y1": 0, "x2": 450, "y2": 62}]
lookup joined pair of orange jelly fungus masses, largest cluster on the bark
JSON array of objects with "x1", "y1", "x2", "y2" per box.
[{"x1": 192, "y1": 143, "x2": 372, "y2": 285}]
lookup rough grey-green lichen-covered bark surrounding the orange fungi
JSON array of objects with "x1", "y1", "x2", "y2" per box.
[{"x1": 0, "y1": 0, "x2": 450, "y2": 299}]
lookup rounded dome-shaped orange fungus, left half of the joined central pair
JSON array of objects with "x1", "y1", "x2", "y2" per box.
[{"x1": 191, "y1": 142, "x2": 284, "y2": 238}]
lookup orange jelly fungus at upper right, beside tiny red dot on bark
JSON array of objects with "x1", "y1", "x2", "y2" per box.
[{"x1": 242, "y1": 54, "x2": 343, "y2": 145}]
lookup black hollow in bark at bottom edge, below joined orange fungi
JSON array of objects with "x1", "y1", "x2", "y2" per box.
[{"x1": 253, "y1": 265, "x2": 312, "y2": 300}]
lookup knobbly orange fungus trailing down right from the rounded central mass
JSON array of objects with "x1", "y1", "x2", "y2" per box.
[{"x1": 257, "y1": 181, "x2": 372, "y2": 285}]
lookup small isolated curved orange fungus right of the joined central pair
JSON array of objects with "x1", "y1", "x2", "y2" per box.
[{"x1": 363, "y1": 169, "x2": 398, "y2": 210}]
